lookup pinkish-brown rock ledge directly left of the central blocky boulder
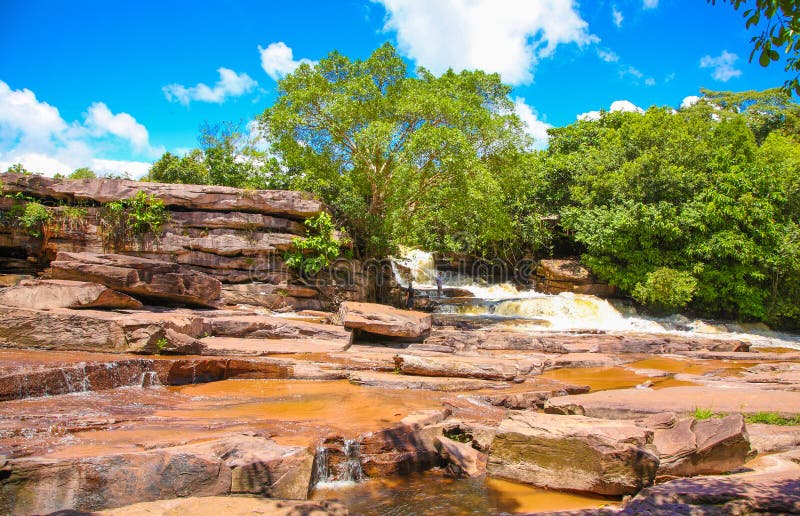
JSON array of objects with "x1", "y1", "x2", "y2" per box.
[{"x1": 207, "y1": 314, "x2": 352, "y2": 345}]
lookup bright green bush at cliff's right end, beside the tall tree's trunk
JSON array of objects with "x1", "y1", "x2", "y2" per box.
[{"x1": 284, "y1": 212, "x2": 342, "y2": 274}]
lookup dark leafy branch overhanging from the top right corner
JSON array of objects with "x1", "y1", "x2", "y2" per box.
[{"x1": 708, "y1": 0, "x2": 800, "y2": 95}]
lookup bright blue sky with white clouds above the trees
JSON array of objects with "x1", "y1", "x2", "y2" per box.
[{"x1": 0, "y1": 0, "x2": 788, "y2": 177}]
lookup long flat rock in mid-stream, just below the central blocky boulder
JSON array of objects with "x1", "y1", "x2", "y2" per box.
[{"x1": 394, "y1": 354, "x2": 546, "y2": 382}]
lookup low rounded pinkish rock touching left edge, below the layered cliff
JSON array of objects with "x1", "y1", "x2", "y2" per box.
[{"x1": 0, "y1": 280, "x2": 142, "y2": 309}]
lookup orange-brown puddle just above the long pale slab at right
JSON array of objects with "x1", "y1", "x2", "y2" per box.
[{"x1": 538, "y1": 367, "x2": 696, "y2": 391}]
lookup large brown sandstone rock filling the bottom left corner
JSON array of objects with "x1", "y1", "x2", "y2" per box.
[{"x1": 0, "y1": 436, "x2": 313, "y2": 514}]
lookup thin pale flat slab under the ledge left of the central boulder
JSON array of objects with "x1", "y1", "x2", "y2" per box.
[{"x1": 200, "y1": 337, "x2": 349, "y2": 356}]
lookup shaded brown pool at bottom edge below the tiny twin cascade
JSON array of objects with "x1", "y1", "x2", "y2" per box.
[{"x1": 311, "y1": 471, "x2": 615, "y2": 516}]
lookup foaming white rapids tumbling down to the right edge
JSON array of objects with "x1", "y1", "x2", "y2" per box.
[{"x1": 392, "y1": 249, "x2": 800, "y2": 350}]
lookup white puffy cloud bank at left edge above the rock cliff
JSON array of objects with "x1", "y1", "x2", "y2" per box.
[{"x1": 0, "y1": 81, "x2": 163, "y2": 176}]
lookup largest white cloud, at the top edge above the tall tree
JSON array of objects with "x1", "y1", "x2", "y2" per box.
[{"x1": 373, "y1": 0, "x2": 599, "y2": 84}]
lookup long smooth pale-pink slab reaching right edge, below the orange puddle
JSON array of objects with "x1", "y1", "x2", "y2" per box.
[{"x1": 545, "y1": 386, "x2": 800, "y2": 418}]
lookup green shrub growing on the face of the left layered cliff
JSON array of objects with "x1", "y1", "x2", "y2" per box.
[{"x1": 99, "y1": 190, "x2": 169, "y2": 250}]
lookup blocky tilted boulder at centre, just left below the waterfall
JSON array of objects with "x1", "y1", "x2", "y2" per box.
[{"x1": 339, "y1": 301, "x2": 432, "y2": 340}]
